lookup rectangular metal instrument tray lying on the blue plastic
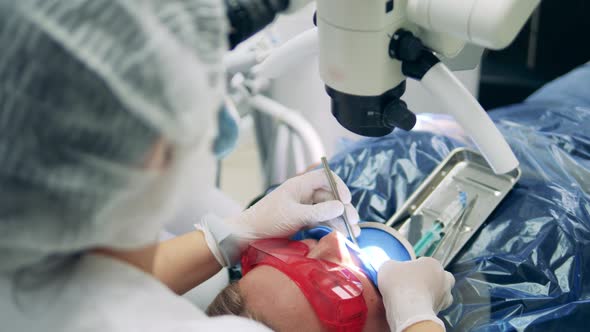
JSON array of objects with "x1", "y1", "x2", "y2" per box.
[{"x1": 386, "y1": 148, "x2": 521, "y2": 266}]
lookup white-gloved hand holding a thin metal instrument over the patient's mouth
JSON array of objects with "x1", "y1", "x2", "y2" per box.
[{"x1": 197, "y1": 170, "x2": 360, "y2": 266}]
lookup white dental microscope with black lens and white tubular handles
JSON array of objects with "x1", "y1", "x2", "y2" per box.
[{"x1": 226, "y1": 0, "x2": 540, "y2": 173}]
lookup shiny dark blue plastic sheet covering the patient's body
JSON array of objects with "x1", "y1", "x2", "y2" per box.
[{"x1": 331, "y1": 65, "x2": 590, "y2": 332}]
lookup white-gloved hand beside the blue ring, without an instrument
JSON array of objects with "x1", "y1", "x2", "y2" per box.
[{"x1": 377, "y1": 257, "x2": 455, "y2": 332}]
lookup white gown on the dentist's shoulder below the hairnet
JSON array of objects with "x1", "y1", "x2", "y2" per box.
[{"x1": 0, "y1": 254, "x2": 269, "y2": 332}]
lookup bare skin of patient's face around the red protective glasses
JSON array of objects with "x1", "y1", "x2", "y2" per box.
[{"x1": 239, "y1": 232, "x2": 389, "y2": 331}]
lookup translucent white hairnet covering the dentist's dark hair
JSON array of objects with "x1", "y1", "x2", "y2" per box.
[{"x1": 0, "y1": 0, "x2": 227, "y2": 270}]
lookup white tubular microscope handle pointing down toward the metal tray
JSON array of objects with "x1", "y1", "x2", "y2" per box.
[{"x1": 420, "y1": 62, "x2": 519, "y2": 174}]
